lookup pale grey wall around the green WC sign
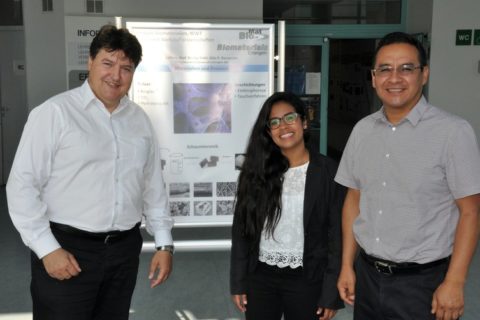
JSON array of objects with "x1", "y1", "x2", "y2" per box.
[{"x1": 429, "y1": 0, "x2": 480, "y2": 139}]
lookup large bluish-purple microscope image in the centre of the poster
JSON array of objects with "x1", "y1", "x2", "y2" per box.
[{"x1": 173, "y1": 83, "x2": 232, "y2": 133}]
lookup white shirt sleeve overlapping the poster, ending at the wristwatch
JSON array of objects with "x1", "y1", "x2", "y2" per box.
[{"x1": 143, "y1": 120, "x2": 173, "y2": 247}]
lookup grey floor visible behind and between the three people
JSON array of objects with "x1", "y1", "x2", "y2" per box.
[{"x1": 0, "y1": 187, "x2": 480, "y2": 320}]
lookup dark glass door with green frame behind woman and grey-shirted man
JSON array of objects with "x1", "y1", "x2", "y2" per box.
[{"x1": 285, "y1": 24, "x2": 404, "y2": 160}]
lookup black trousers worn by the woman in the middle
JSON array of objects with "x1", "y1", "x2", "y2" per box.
[{"x1": 246, "y1": 262, "x2": 322, "y2": 320}]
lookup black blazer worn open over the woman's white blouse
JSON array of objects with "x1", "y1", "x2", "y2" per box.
[{"x1": 230, "y1": 152, "x2": 346, "y2": 309}]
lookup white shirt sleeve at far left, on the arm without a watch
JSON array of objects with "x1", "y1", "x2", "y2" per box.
[{"x1": 7, "y1": 102, "x2": 60, "y2": 259}]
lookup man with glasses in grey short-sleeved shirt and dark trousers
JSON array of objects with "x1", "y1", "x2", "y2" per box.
[{"x1": 335, "y1": 32, "x2": 480, "y2": 320}]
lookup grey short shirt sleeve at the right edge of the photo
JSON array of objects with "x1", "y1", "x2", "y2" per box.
[{"x1": 446, "y1": 120, "x2": 480, "y2": 199}]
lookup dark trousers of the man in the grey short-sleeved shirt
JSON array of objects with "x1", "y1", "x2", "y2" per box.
[{"x1": 353, "y1": 255, "x2": 448, "y2": 320}]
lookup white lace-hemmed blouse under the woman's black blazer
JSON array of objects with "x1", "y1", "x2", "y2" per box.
[{"x1": 258, "y1": 162, "x2": 308, "y2": 269}]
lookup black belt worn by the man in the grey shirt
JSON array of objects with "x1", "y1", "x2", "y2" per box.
[{"x1": 360, "y1": 249, "x2": 450, "y2": 274}]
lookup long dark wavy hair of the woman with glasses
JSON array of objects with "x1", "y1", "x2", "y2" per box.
[{"x1": 234, "y1": 92, "x2": 308, "y2": 241}]
